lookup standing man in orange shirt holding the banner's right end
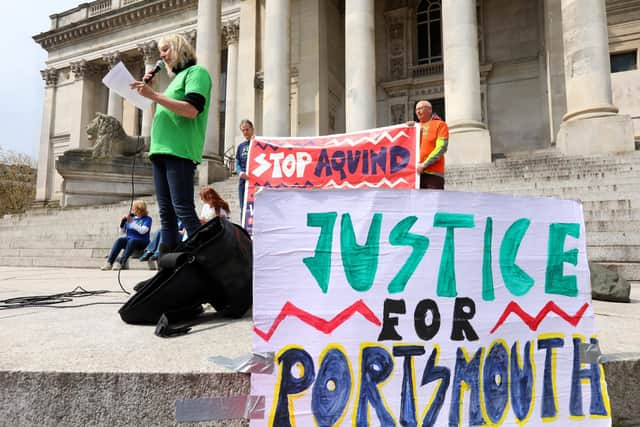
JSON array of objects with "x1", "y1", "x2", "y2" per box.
[{"x1": 416, "y1": 100, "x2": 449, "y2": 190}]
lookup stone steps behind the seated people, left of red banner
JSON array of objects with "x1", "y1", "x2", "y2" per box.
[{"x1": 0, "y1": 177, "x2": 240, "y2": 269}]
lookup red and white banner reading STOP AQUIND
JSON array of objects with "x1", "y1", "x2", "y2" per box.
[{"x1": 242, "y1": 125, "x2": 419, "y2": 233}]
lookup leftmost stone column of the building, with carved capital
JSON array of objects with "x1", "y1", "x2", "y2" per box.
[{"x1": 35, "y1": 68, "x2": 58, "y2": 205}]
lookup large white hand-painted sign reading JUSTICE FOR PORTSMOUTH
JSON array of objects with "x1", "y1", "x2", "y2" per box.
[{"x1": 251, "y1": 190, "x2": 611, "y2": 427}]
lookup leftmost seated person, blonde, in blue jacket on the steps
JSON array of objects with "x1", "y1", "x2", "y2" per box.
[{"x1": 100, "y1": 200, "x2": 151, "y2": 270}]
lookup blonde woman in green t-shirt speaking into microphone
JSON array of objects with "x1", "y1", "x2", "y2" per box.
[{"x1": 130, "y1": 34, "x2": 212, "y2": 255}]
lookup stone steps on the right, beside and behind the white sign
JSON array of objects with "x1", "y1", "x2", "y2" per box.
[{"x1": 446, "y1": 151, "x2": 640, "y2": 281}]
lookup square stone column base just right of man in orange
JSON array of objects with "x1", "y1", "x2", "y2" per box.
[{"x1": 445, "y1": 122, "x2": 491, "y2": 166}]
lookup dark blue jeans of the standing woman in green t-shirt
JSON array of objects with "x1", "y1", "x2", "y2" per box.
[{"x1": 151, "y1": 154, "x2": 200, "y2": 249}]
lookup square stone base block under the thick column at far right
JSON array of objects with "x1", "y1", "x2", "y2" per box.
[{"x1": 557, "y1": 114, "x2": 635, "y2": 155}]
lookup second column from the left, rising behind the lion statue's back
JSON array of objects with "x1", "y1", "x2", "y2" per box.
[{"x1": 69, "y1": 59, "x2": 100, "y2": 148}]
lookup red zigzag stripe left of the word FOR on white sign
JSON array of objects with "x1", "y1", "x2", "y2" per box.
[{"x1": 253, "y1": 300, "x2": 382, "y2": 341}]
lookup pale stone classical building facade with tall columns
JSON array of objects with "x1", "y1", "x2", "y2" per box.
[{"x1": 34, "y1": 0, "x2": 640, "y2": 206}]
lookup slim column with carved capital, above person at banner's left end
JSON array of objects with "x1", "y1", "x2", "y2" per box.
[{"x1": 222, "y1": 19, "x2": 240, "y2": 162}]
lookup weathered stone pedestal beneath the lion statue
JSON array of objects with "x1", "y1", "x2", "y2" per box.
[{"x1": 56, "y1": 150, "x2": 153, "y2": 207}]
